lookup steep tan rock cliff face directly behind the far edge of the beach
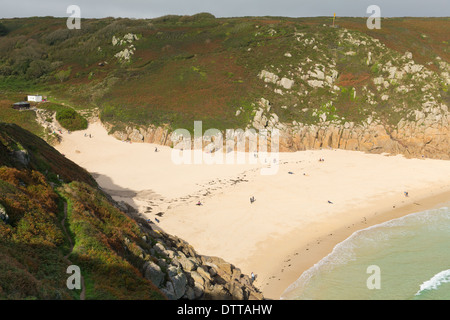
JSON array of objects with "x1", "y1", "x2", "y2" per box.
[{"x1": 107, "y1": 99, "x2": 450, "y2": 159}]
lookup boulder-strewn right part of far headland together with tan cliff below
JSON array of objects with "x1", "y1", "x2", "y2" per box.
[{"x1": 107, "y1": 25, "x2": 450, "y2": 159}]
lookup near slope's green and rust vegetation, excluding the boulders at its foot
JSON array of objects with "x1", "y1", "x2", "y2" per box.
[{"x1": 0, "y1": 123, "x2": 164, "y2": 299}]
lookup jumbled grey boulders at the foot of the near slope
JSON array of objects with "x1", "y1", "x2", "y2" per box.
[{"x1": 122, "y1": 203, "x2": 264, "y2": 300}]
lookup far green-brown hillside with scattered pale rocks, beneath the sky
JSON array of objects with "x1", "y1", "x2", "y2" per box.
[{"x1": 0, "y1": 13, "x2": 450, "y2": 134}]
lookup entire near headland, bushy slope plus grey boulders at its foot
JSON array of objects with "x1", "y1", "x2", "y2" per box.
[{"x1": 0, "y1": 123, "x2": 263, "y2": 300}]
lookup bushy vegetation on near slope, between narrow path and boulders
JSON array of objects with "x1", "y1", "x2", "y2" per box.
[{"x1": 61, "y1": 182, "x2": 162, "y2": 300}]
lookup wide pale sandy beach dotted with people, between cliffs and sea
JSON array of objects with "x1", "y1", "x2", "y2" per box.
[{"x1": 56, "y1": 122, "x2": 450, "y2": 299}]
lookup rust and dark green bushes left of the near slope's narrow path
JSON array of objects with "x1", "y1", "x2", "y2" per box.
[{"x1": 0, "y1": 167, "x2": 71, "y2": 299}]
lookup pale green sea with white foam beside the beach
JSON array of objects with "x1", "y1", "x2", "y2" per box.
[{"x1": 282, "y1": 207, "x2": 450, "y2": 300}]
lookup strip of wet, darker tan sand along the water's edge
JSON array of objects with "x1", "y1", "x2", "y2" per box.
[{"x1": 250, "y1": 189, "x2": 450, "y2": 300}]
